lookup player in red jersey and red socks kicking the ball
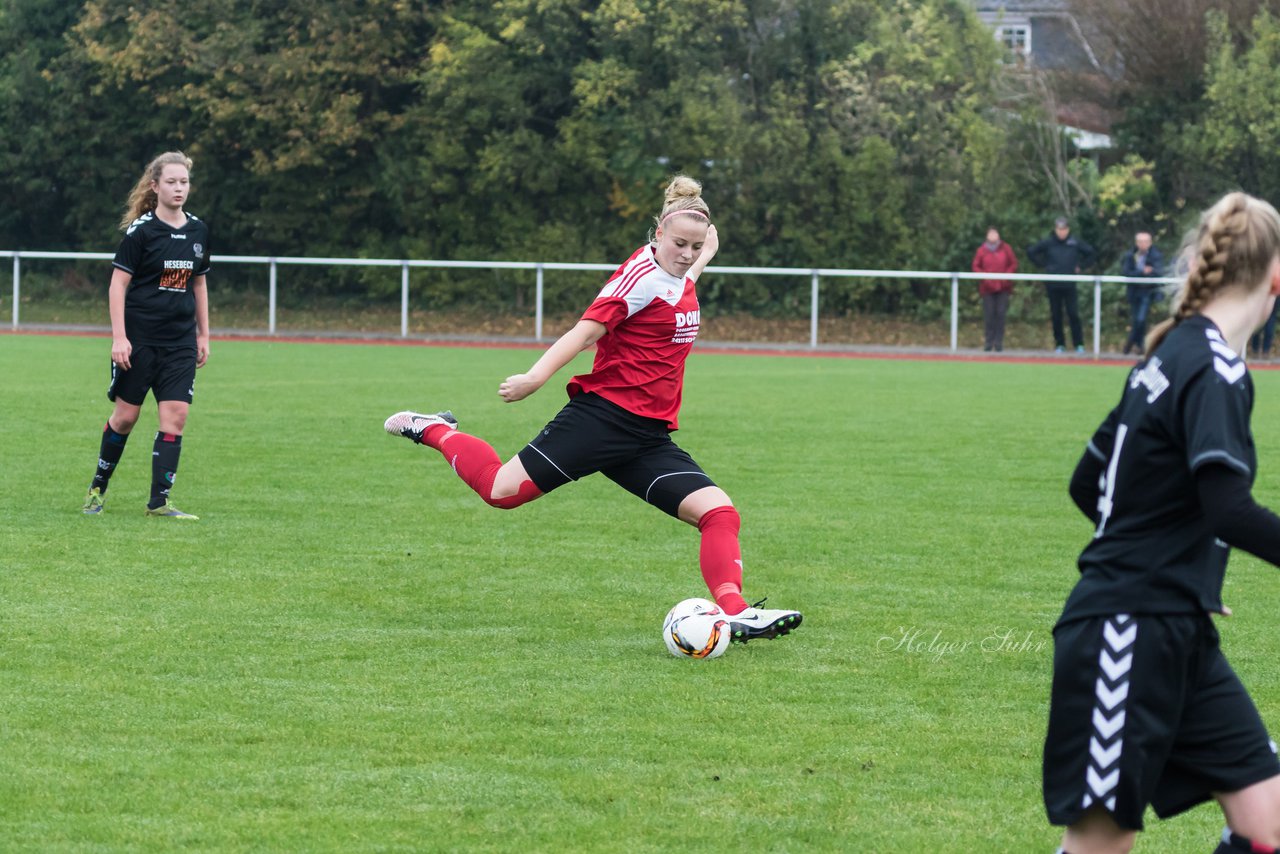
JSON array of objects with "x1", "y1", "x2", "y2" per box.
[{"x1": 384, "y1": 175, "x2": 803, "y2": 643}]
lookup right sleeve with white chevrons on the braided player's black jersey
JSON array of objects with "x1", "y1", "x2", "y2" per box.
[{"x1": 1180, "y1": 356, "x2": 1254, "y2": 483}]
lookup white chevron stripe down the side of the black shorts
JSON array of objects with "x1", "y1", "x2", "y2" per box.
[{"x1": 1080, "y1": 613, "x2": 1138, "y2": 812}]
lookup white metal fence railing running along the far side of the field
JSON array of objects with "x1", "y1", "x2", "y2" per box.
[{"x1": 0, "y1": 250, "x2": 1179, "y2": 355}]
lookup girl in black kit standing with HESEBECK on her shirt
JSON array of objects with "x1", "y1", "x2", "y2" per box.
[{"x1": 84, "y1": 151, "x2": 209, "y2": 520}]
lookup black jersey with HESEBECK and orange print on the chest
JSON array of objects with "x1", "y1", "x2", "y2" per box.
[{"x1": 111, "y1": 213, "x2": 209, "y2": 346}]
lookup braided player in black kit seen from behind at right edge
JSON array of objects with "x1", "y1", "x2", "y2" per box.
[{"x1": 1044, "y1": 193, "x2": 1280, "y2": 854}]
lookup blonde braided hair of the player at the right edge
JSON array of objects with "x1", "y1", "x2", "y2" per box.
[{"x1": 1146, "y1": 192, "x2": 1280, "y2": 353}]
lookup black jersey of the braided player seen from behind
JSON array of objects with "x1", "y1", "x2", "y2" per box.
[{"x1": 1060, "y1": 315, "x2": 1257, "y2": 622}]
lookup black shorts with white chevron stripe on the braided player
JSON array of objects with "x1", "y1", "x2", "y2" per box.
[{"x1": 1044, "y1": 615, "x2": 1280, "y2": 830}]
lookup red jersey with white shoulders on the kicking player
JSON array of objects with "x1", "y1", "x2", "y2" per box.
[{"x1": 568, "y1": 245, "x2": 699, "y2": 430}]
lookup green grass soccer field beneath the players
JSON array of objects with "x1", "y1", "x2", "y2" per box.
[{"x1": 0, "y1": 334, "x2": 1280, "y2": 853}]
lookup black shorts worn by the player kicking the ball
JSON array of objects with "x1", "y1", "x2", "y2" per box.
[{"x1": 518, "y1": 392, "x2": 716, "y2": 516}]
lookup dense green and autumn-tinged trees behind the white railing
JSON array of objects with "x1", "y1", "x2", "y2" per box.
[{"x1": 0, "y1": 0, "x2": 1280, "y2": 309}]
